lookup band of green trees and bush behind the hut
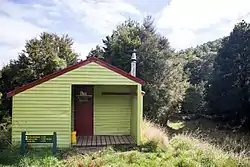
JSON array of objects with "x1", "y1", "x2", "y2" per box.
[{"x1": 0, "y1": 16, "x2": 250, "y2": 129}]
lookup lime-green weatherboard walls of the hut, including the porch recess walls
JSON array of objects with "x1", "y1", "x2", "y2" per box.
[{"x1": 12, "y1": 62, "x2": 142, "y2": 147}]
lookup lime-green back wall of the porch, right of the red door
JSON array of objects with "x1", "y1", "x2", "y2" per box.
[{"x1": 94, "y1": 86, "x2": 132, "y2": 135}]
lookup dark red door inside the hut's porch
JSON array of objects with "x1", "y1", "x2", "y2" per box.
[{"x1": 73, "y1": 85, "x2": 93, "y2": 136}]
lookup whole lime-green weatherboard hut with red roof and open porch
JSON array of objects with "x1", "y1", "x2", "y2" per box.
[{"x1": 8, "y1": 57, "x2": 144, "y2": 147}]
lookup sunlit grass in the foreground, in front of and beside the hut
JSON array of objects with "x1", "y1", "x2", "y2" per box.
[{"x1": 0, "y1": 121, "x2": 250, "y2": 167}]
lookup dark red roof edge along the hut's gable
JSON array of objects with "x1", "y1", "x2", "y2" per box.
[{"x1": 8, "y1": 57, "x2": 145, "y2": 97}]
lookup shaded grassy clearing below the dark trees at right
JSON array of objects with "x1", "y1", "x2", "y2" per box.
[{"x1": 168, "y1": 119, "x2": 250, "y2": 156}]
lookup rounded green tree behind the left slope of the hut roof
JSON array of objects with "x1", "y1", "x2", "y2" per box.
[{"x1": 23, "y1": 33, "x2": 77, "y2": 78}]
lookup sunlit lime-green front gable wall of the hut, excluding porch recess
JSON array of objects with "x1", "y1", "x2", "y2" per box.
[{"x1": 12, "y1": 62, "x2": 138, "y2": 147}]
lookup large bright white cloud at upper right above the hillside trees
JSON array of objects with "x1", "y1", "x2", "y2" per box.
[{"x1": 157, "y1": 0, "x2": 250, "y2": 49}]
